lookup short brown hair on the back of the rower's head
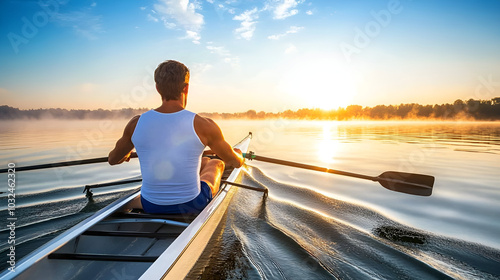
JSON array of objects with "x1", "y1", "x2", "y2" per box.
[{"x1": 155, "y1": 60, "x2": 189, "y2": 100}]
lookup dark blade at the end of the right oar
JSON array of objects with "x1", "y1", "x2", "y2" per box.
[{"x1": 377, "y1": 171, "x2": 434, "y2": 196}]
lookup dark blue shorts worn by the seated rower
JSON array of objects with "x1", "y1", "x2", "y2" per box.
[{"x1": 141, "y1": 181, "x2": 212, "y2": 214}]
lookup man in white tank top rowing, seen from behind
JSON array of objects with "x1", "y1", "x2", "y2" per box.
[{"x1": 108, "y1": 60, "x2": 244, "y2": 214}]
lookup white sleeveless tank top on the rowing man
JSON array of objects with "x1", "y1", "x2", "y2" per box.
[{"x1": 132, "y1": 110, "x2": 205, "y2": 205}]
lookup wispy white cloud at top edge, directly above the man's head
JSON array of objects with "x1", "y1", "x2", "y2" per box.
[{"x1": 154, "y1": 0, "x2": 204, "y2": 44}]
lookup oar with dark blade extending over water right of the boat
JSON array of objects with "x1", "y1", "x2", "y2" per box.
[{"x1": 243, "y1": 152, "x2": 434, "y2": 196}]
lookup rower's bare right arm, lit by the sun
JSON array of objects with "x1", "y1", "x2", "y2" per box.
[{"x1": 195, "y1": 116, "x2": 244, "y2": 167}]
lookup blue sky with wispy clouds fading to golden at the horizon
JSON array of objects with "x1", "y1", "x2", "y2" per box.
[{"x1": 0, "y1": 0, "x2": 500, "y2": 113}]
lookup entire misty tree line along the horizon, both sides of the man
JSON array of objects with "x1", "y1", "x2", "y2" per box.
[{"x1": 0, "y1": 97, "x2": 500, "y2": 120}]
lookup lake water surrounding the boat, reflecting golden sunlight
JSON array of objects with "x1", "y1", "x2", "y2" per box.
[{"x1": 0, "y1": 120, "x2": 500, "y2": 279}]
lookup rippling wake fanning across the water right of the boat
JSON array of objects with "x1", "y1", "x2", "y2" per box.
[{"x1": 190, "y1": 167, "x2": 500, "y2": 279}]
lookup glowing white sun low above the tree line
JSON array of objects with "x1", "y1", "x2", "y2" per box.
[{"x1": 279, "y1": 60, "x2": 356, "y2": 110}]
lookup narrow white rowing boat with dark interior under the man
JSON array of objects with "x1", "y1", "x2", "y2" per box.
[{"x1": 0, "y1": 134, "x2": 251, "y2": 280}]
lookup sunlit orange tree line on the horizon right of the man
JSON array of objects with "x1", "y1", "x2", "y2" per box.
[{"x1": 201, "y1": 97, "x2": 500, "y2": 120}]
